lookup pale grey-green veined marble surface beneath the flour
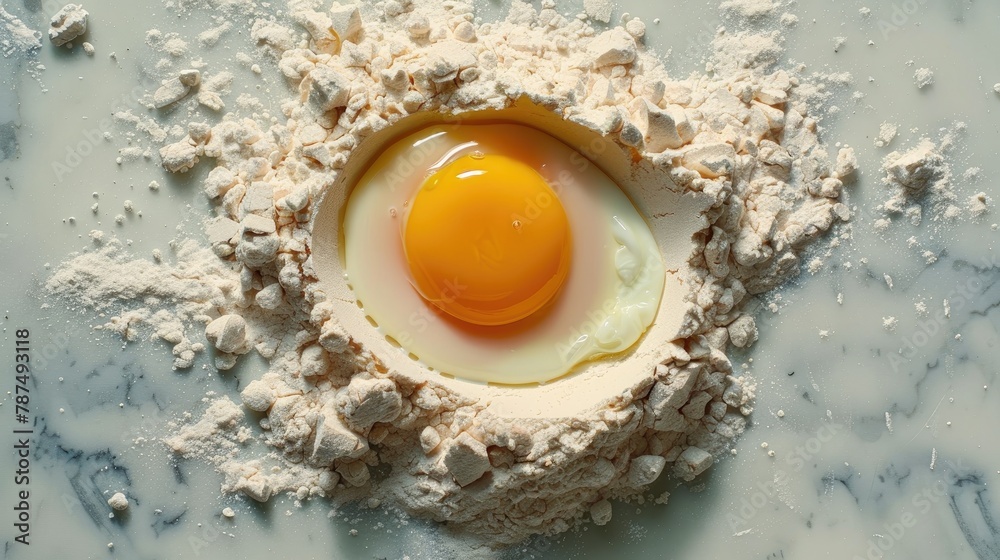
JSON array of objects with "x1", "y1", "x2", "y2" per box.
[{"x1": 0, "y1": 0, "x2": 1000, "y2": 560}]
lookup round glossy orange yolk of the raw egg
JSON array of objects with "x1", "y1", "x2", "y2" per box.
[{"x1": 403, "y1": 152, "x2": 572, "y2": 326}]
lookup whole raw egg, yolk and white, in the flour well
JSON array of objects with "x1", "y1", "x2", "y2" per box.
[{"x1": 339, "y1": 122, "x2": 666, "y2": 385}]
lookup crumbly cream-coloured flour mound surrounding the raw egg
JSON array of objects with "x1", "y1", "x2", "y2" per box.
[{"x1": 47, "y1": 0, "x2": 857, "y2": 543}]
